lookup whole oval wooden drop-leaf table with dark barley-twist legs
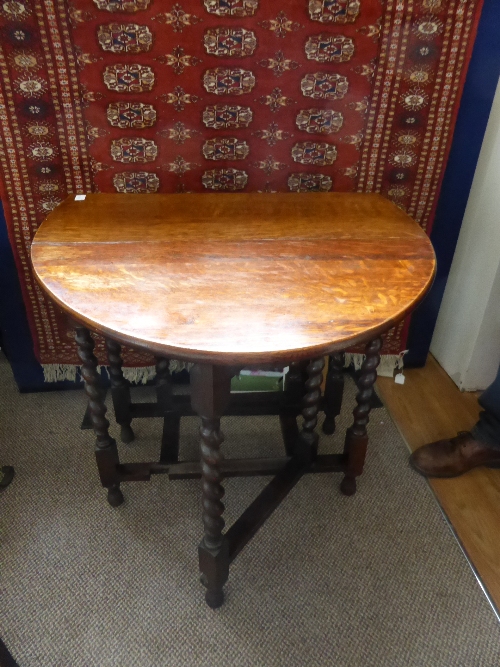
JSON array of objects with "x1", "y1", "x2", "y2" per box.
[{"x1": 32, "y1": 193, "x2": 435, "y2": 607}]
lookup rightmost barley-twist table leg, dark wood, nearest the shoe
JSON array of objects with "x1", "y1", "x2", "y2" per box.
[{"x1": 340, "y1": 338, "x2": 382, "y2": 496}]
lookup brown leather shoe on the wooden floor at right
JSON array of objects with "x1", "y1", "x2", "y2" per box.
[{"x1": 410, "y1": 431, "x2": 500, "y2": 477}]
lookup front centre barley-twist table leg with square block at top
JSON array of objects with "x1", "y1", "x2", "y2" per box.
[{"x1": 191, "y1": 364, "x2": 231, "y2": 609}]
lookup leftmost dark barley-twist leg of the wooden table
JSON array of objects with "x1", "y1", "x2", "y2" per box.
[{"x1": 75, "y1": 326, "x2": 123, "y2": 507}]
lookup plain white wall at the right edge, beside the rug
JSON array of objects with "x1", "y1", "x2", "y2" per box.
[{"x1": 431, "y1": 81, "x2": 500, "y2": 391}]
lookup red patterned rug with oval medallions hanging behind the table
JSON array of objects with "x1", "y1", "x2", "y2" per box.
[{"x1": 0, "y1": 0, "x2": 482, "y2": 380}]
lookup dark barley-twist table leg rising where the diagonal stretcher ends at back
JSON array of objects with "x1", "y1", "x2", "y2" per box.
[{"x1": 296, "y1": 357, "x2": 325, "y2": 462}]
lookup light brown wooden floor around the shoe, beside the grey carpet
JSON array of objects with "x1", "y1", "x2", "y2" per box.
[{"x1": 377, "y1": 356, "x2": 500, "y2": 610}]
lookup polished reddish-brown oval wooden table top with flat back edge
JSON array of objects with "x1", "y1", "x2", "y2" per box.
[{"x1": 32, "y1": 193, "x2": 435, "y2": 364}]
